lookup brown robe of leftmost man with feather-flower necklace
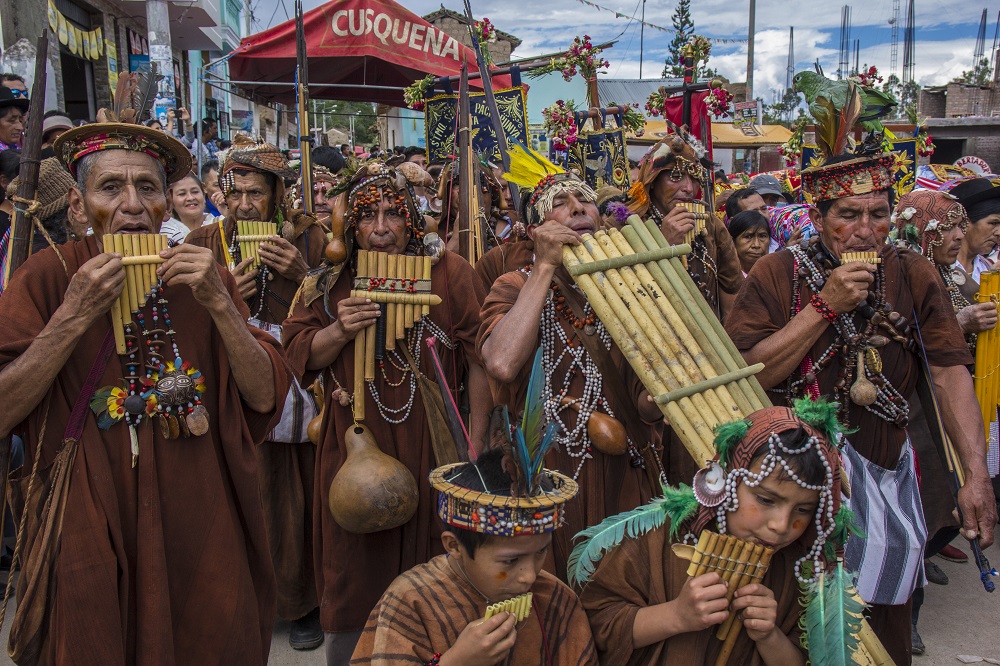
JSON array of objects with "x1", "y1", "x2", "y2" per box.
[{"x1": 0, "y1": 237, "x2": 290, "y2": 664}]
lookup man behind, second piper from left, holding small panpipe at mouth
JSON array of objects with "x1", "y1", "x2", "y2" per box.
[{"x1": 186, "y1": 135, "x2": 326, "y2": 650}]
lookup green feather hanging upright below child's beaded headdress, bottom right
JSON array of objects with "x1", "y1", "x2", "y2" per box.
[{"x1": 801, "y1": 562, "x2": 865, "y2": 666}]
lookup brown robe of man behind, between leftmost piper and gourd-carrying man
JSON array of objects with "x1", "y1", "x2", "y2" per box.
[{"x1": 184, "y1": 217, "x2": 326, "y2": 620}]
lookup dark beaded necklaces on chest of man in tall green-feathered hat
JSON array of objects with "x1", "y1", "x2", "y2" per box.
[{"x1": 785, "y1": 239, "x2": 913, "y2": 428}]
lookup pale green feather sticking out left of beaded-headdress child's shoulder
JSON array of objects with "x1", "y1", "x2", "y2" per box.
[{"x1": 566, "y1": 497, "x2": 667, "y2": 585}]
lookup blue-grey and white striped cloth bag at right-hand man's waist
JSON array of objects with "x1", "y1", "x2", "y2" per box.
[{"x1": 842, "y1": 440, "x2": 927, "y2": 605}]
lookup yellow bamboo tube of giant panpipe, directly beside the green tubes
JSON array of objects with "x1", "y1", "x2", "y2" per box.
[{"x1": 608, "y1": 227, "x2": 754, "y2": 415}]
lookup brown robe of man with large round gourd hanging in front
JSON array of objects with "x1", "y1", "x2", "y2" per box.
[{"x1": 284, "y1": 246, "x2": 483, "y2": 632}]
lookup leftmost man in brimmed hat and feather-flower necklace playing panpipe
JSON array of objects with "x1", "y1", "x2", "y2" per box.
[{"x1": 0, "y1": 106, "x2": 291, "y2": 664}]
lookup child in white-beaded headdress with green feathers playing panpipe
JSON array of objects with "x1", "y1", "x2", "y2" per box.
[{"x1": 569, "y1": 400, "x2": 860, "y2": 665}]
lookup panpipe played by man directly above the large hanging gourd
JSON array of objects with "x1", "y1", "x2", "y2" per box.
[{"x1": 351, "y1": 250, "x2": 441, "y2": 421}]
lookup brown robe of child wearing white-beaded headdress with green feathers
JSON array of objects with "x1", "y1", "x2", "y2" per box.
[{"x1": 580, "y1": 525, "x2": 802, "y2": 666}]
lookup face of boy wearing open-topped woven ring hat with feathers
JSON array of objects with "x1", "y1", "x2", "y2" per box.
[{"x1": 448, "y1": 533, "x2": 552, "y2": 603}]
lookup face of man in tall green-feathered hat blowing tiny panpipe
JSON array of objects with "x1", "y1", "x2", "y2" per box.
[{"x1": 809, "y1": 191, "x2": 892, "y2": 261}]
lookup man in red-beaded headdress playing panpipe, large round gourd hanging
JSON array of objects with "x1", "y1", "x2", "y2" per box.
[{"x1": 284, "y1": 161, "x2": 491, "y2": 664}]
